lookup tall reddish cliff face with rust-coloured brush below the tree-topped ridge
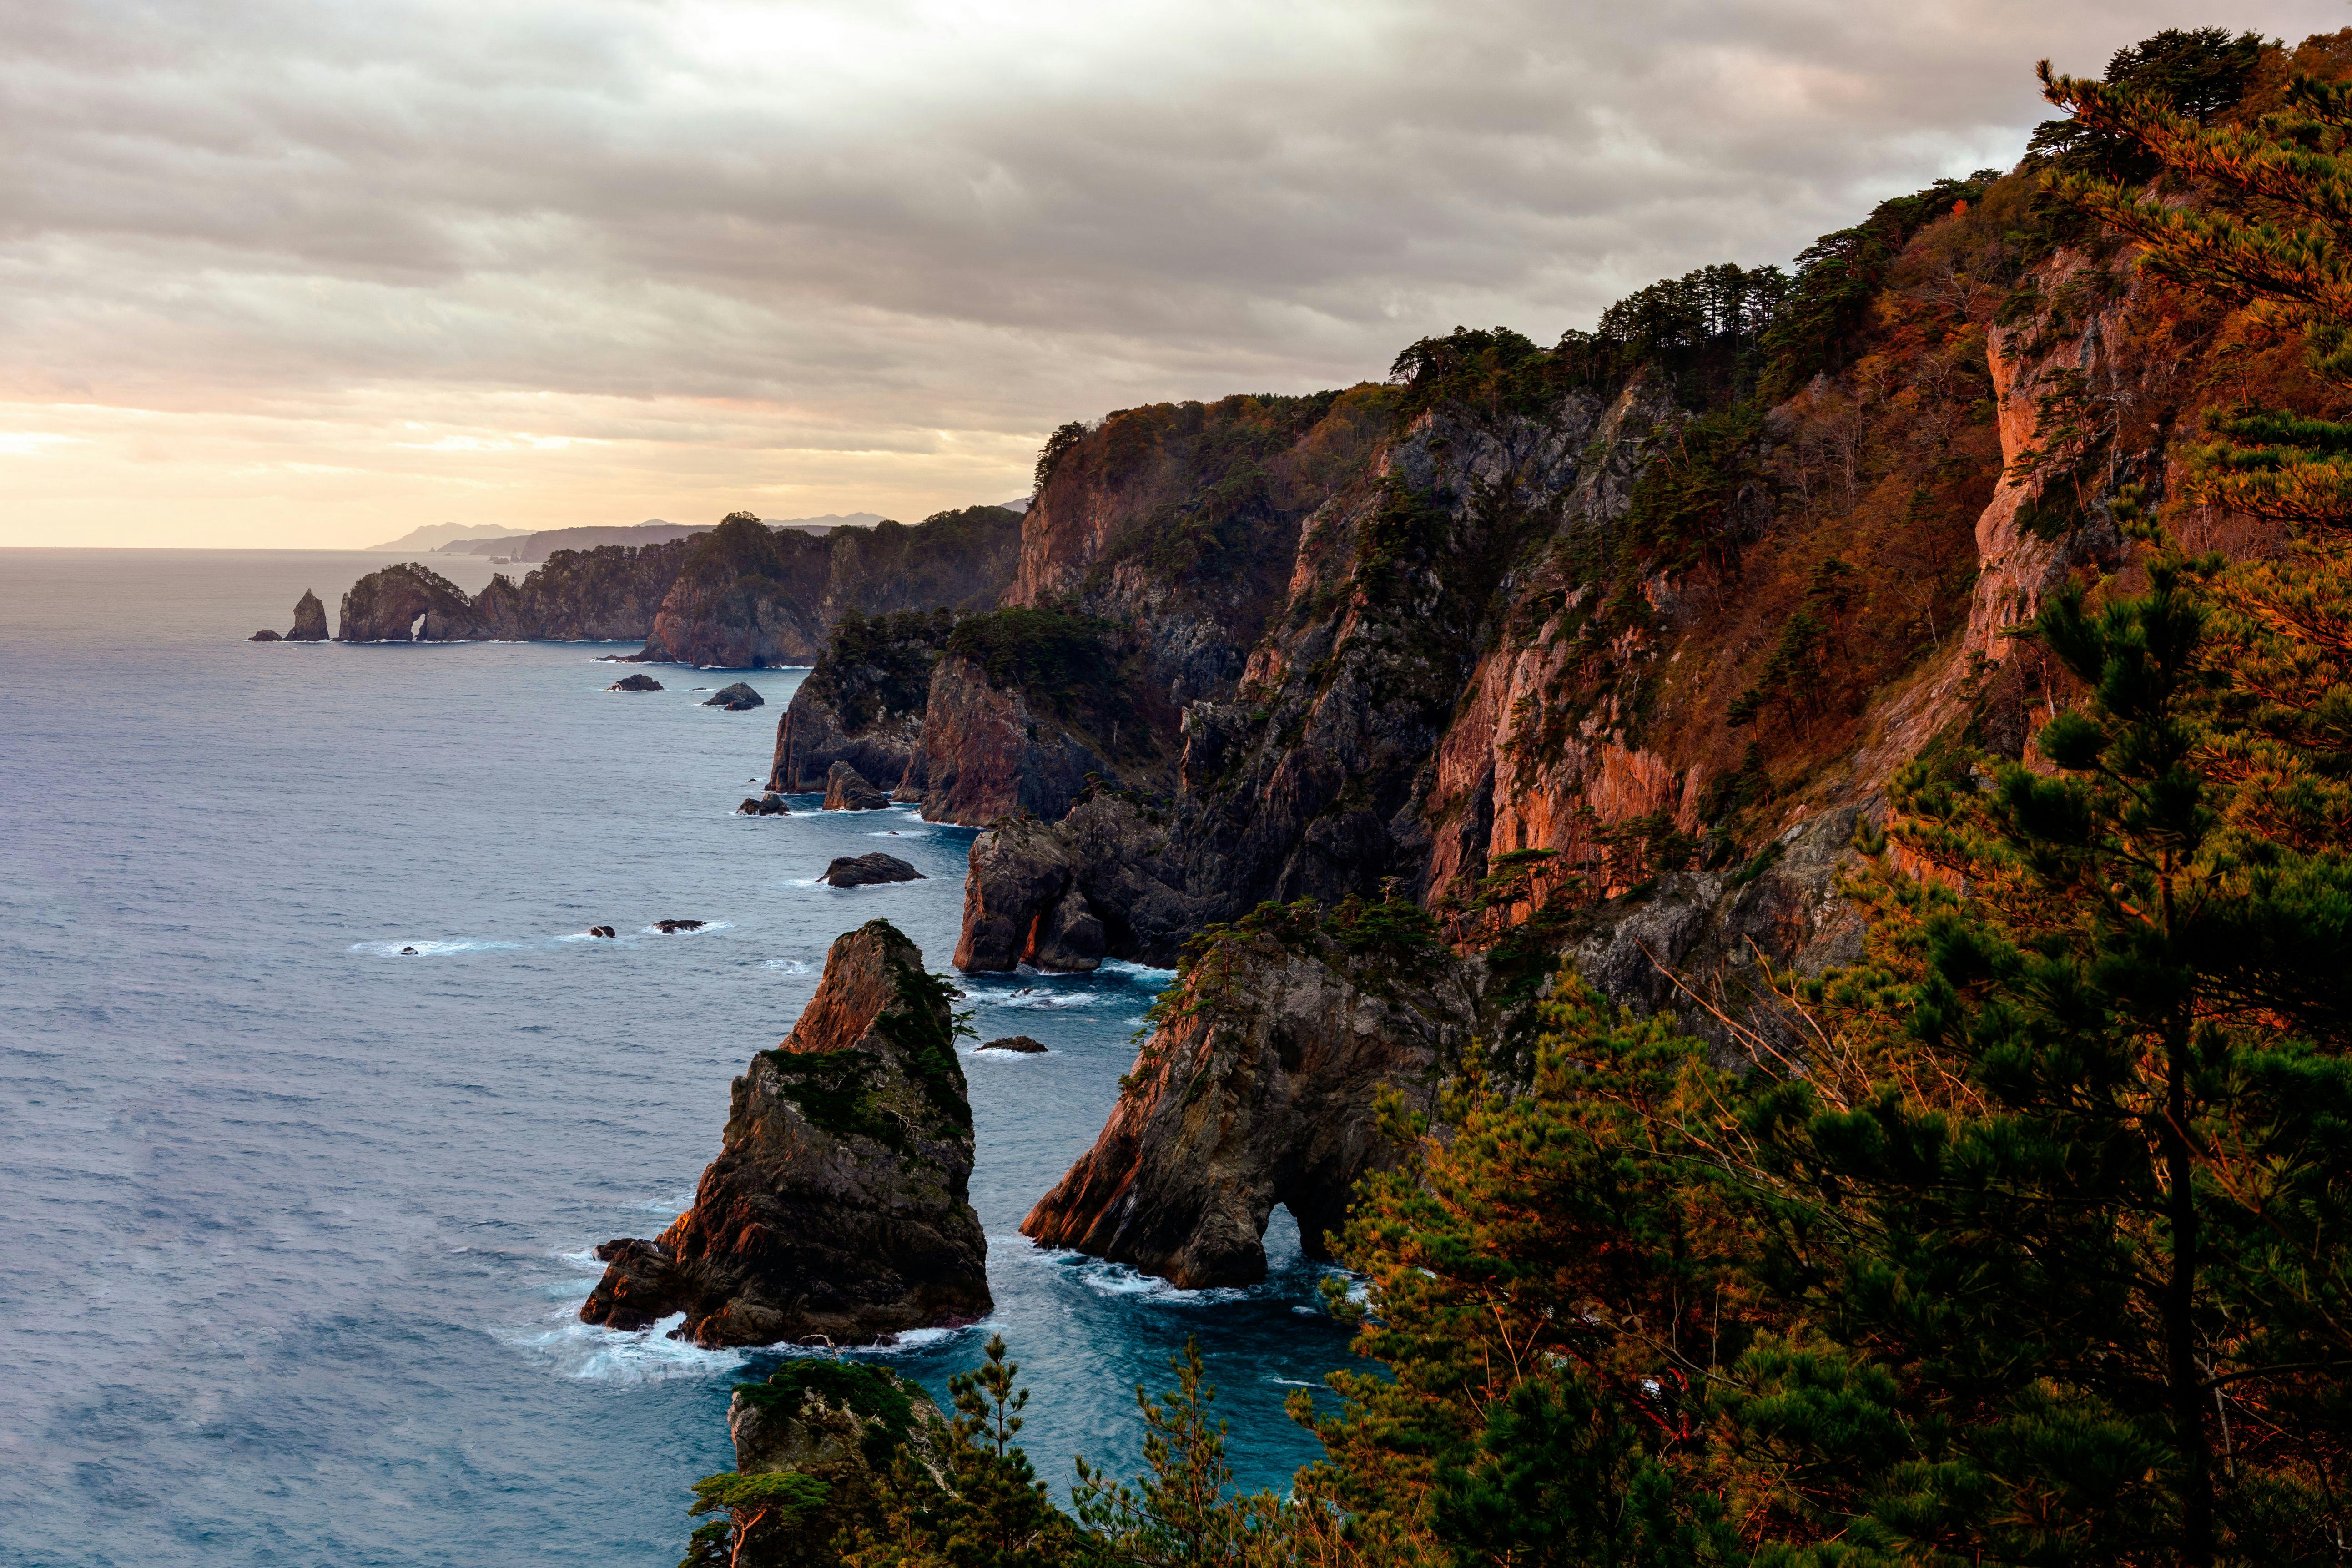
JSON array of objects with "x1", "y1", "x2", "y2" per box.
[{"x1": 957, "y1": 166, "x2": 2328, "y2": 1053}]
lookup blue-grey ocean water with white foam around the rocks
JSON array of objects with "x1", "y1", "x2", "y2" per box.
[{"x1": 0, "y1": 550, "x2": 1348, "y2": 1568}]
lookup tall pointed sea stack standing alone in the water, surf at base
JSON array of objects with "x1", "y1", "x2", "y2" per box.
[{"x1": 581, "y1": 919, "x2": 990, "y2": 1345}]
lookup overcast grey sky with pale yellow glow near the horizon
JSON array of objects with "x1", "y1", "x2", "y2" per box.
[{"x1": 0, "y1": 0, "x2": 2352, "y2": 548}]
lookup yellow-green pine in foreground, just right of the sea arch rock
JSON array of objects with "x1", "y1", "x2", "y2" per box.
[{"x1": 1296, "y1": 973, "x2": 1752, "y2": 1566}]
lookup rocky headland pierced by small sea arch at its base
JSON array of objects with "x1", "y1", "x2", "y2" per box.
[{"x1": 1021, "y1": 910, "x2": 1477, "y2": 1288}]
